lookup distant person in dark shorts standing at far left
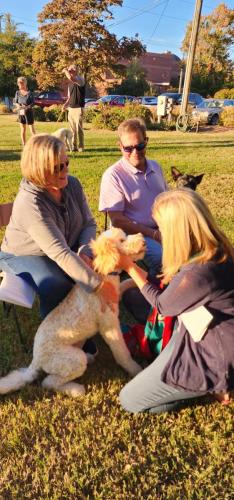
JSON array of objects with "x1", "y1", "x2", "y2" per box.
[{"x1": 14, "y1": 76, "x2": 36, "y2": 146}]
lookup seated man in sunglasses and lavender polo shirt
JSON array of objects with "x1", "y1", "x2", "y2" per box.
[{"x1": 99, "y1": 118, "x2": 168, "y2": 275}]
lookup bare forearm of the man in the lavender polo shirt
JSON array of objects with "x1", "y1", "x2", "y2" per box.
[{"x1": 108, "y1": 211, "x2": 161, "y2": 243}]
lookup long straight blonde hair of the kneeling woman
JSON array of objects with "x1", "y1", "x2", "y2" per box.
[{"x1": 152, "y1": 188, "x2": 234, "y2": 283}]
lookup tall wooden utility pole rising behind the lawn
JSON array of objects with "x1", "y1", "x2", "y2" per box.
[{"x1": 177, "y1": 0, "x2": 203, "y2": 130}]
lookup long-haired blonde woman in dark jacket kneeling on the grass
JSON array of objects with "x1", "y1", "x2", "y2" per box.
[{"x1": 119, "y1": 189, "x2": 234, "y2": 413}]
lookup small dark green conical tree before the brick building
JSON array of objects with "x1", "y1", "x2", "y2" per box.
[{"x1": 109, "y1": 58, "x2": 150, "y2": 96}]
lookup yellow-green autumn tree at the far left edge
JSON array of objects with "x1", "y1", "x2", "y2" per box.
[{"x1": 0, "y1": 14, "x2": 36, "y2": 97}]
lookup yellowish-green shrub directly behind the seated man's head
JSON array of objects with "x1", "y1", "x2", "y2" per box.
[{"x1": 92, "y1": 103, "x2": 153, "y2": 130}]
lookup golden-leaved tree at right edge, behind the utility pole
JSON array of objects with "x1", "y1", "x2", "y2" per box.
[{"x1": 182, "y1": 3, "x2": 234, "y2": 95}]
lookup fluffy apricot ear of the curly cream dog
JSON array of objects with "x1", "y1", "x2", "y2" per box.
[{"x1": 91, "y1": 234, "x2": 119, "y2": 276}]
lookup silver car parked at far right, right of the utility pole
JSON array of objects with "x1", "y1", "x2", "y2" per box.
[{"x1": 192, "y1": 99, "x2": 234, "y2": 125}]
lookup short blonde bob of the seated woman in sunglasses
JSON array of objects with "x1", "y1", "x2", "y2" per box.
[{"x1": 21, "y1": 134, "x2": 64, "y2": 188}]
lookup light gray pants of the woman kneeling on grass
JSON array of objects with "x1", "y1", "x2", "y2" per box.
[{"x1": 120, "y1": 330, "x2": 205, "y2": 413}]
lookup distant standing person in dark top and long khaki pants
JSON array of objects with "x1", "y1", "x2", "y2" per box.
[{"x1": 63, "y1": 64, "x2": 85, "y2": 153}]
